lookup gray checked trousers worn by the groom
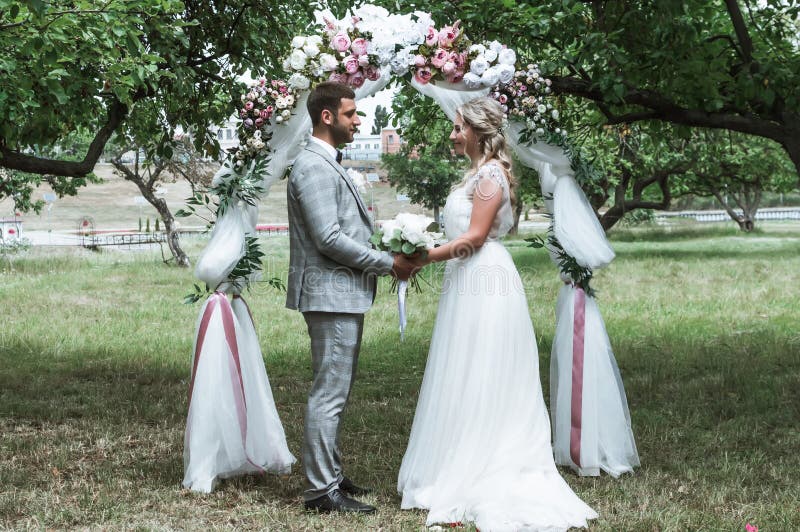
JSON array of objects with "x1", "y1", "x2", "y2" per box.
[{"x1": 303, "y1": 312, "x2": 364, "y2": 501}]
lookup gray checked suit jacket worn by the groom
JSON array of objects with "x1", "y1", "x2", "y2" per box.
[{"x1": 286, "y1": 142, "x2": 394, "y2": 314}]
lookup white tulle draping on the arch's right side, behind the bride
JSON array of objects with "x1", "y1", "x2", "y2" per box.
[{"x1": 411, "y1": 80, "x2": 639, "y2": 476}]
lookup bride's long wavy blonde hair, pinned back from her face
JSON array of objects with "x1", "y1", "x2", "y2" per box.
[{"x1": 456, "y1": 97, "x2": 517, "y2": 206}]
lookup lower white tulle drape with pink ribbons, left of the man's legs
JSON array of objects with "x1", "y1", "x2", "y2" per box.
[{"x1": 183, "y1": 292, "x2": 295, "y2": 493}]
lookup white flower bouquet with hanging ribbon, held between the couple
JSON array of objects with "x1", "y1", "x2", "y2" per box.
[{"x1": 370, "y1": 212, "x2": 444, "y2": 339}]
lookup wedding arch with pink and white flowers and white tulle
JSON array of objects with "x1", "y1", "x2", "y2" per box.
[{"x1": 187, "y1": 5, "x2": 638, "y2": 492}]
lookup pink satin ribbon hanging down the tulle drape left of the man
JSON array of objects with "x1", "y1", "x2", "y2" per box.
[{"x1": 187, "y1": 292, "x2": 264, "y2": 472}]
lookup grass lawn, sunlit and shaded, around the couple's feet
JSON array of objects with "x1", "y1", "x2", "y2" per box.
[{"x1": 0, "y1": 224, "x2": 800, "y2": 531}]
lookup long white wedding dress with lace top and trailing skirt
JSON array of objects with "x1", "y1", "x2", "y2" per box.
[{"x1": 397, "y1": 163, "x2": 597, "y2": 532}]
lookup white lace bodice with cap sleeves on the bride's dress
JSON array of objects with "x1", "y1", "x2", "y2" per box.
[{"x1": 443, "y1": 162, "x2": 514, "y2": 240}]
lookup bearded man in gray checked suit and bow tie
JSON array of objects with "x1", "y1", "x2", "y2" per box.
[{"x1": 286, "y1": 83, "x2": 414, "y2": 513}]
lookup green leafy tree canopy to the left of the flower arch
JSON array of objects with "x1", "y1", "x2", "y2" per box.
[{"x1": 0, "y1": 0, "x2": 317, "y2": 171}]
